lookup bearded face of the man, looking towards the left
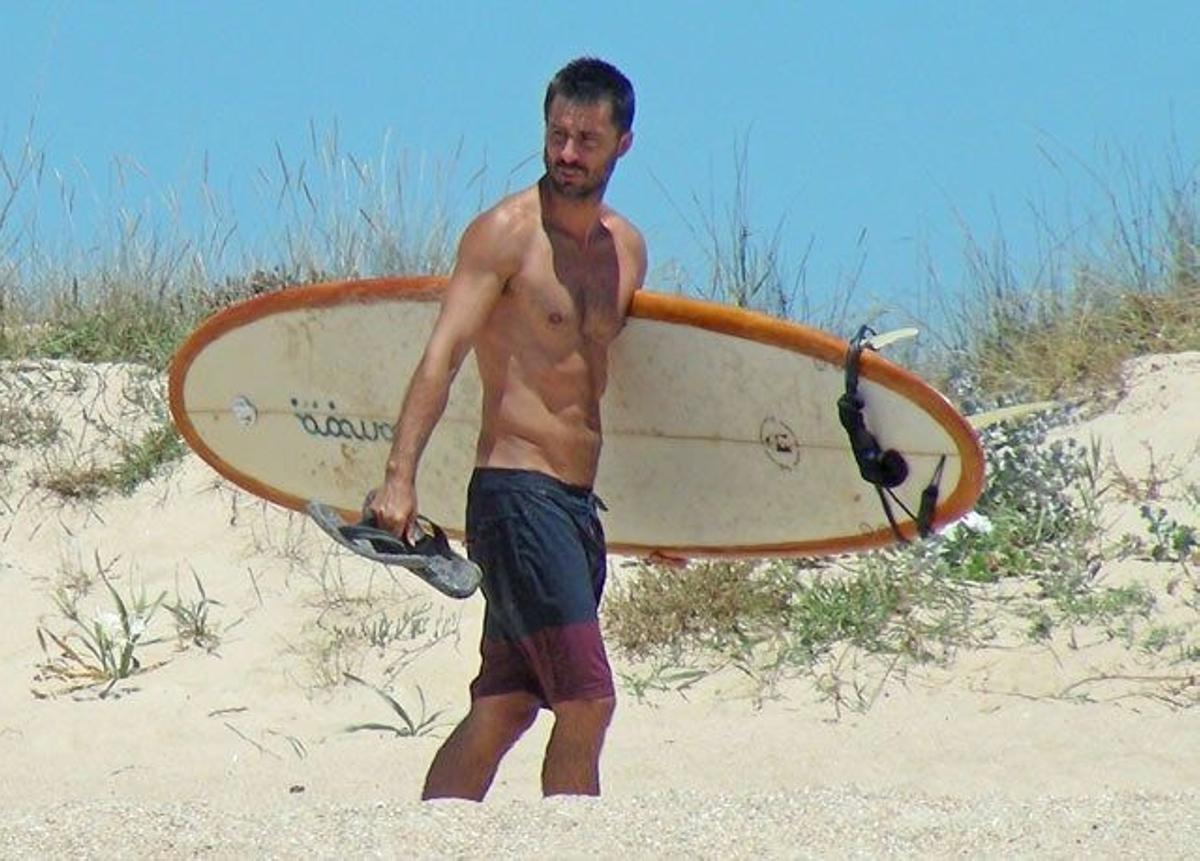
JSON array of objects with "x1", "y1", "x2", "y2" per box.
[{"x1": 544, "y1": 96, "x2": 634, "y2": 200}]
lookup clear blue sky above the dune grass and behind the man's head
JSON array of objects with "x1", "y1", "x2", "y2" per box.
[{"x1": 0, "y1": 0, "x2": 1200, "y2": 326}]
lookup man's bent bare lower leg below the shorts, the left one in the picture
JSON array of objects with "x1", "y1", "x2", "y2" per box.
[{"x1": 421, "y1": 692, "x2": 539, "y2": 801}]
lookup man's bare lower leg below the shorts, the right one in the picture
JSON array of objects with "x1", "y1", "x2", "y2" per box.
[{"x1": 541, "y1": 697, "x2": 617, "y2": 795}]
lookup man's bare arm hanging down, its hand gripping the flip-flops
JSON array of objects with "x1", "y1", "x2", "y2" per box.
[{"x1": 371, "y1": 210, "x2": 520, "y2": 535}]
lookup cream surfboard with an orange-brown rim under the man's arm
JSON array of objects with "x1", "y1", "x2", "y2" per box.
[{"x1": 169, "y1": 277, "x2": 984, "y2": 558}]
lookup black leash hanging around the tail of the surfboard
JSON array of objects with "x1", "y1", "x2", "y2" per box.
[{"x1": 838, "y1": 325, "x2": 946, "y2": 544}]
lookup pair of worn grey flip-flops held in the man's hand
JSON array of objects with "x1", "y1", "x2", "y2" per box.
[{"x1": 305, "y1": 500, "x2": 482, "y2": 598}]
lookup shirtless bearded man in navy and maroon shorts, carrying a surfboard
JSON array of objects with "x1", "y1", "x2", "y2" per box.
[{"x1": 371, "y1": 59, "x2": 646, "y2": 800}]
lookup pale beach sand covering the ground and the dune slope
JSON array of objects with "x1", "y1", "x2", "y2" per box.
[{"x1": 0, "y1": 354, "x2": 1200, "y2": 857}]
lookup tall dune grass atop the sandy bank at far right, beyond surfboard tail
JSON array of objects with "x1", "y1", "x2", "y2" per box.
[{"x1": 942, "y1": 161, "x2": 1200, "y2": 399}]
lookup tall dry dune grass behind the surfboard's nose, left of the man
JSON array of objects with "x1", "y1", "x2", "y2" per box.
[{"x1": 0, "y1": 125, "x2": 458, "y2": 371}]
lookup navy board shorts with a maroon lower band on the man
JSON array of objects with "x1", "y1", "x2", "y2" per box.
[{"x1": 467, "y1": 468, "x2": 613, "y2": 708}]
